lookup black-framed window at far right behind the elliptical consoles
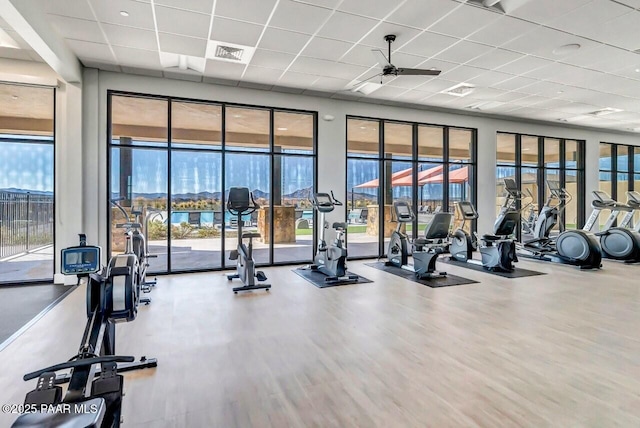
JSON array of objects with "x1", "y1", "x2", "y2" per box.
[{"x1": 599, "y1": 143, "x2": 640, "y2": 231}]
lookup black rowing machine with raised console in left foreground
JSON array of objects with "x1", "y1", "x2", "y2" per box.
[{"x1": 12, "y1": 235, "x2": 158, "y2": 428}]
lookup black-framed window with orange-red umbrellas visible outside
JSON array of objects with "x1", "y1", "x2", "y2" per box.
[{"x1": 347, "y1": 117, "x2": 476, "y2": 258}]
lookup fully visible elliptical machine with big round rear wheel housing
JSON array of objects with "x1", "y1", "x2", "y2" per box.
[{"x1": 518, "y1": 180, "x2": 602, "y2": 269}]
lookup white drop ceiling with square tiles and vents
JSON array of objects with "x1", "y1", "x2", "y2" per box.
[{"x1": 6, "y1": 0, "x2": 640, "y2": 131}]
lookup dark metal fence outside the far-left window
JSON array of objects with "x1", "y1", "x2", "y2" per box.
[{"x1": 0, "y1": 192, "x2": 53, "y2": 259}]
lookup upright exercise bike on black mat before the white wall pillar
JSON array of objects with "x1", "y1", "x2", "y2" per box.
[{"x1": 309, "y1": 192, "x2": 359, "y2": 284}]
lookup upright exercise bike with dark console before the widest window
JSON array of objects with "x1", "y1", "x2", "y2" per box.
[{"x1": 227, "y1": 187, "x2": 271, "y2": 294}]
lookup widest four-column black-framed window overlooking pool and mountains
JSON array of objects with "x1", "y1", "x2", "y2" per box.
[{"x1": 109, "y1": 92, "x2": 316, "y2": 272}]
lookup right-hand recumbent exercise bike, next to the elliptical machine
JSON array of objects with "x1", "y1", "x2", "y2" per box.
[{"x1": 449, "y1": 178, "x2": 522, "y2": 272}]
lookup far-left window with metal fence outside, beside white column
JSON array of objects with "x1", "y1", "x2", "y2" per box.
[{"x1": 0, "y1": 83, "x2": 55, "y2": 284}]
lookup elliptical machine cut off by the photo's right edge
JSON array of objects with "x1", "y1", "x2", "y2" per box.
[{"x1": 583, "y1": 190, "x2": 640, "y2": 263}]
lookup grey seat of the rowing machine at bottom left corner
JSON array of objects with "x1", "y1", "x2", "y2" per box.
[{"x1": 11, "y1": 398, "x2": 107, "y2": 428}]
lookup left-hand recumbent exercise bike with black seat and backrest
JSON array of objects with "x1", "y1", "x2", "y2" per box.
[{"x1": 385, "y1": 201, "x2": 453, "y2": 279}]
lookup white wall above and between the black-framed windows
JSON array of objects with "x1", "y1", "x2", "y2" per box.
[{"x1": 65, "y1": 69, "x2": 640, "y2": 278}]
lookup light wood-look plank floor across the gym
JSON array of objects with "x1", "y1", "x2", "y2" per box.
[{"x1": 0, "y1": 261, "x2": 640, "y2": 428}]
